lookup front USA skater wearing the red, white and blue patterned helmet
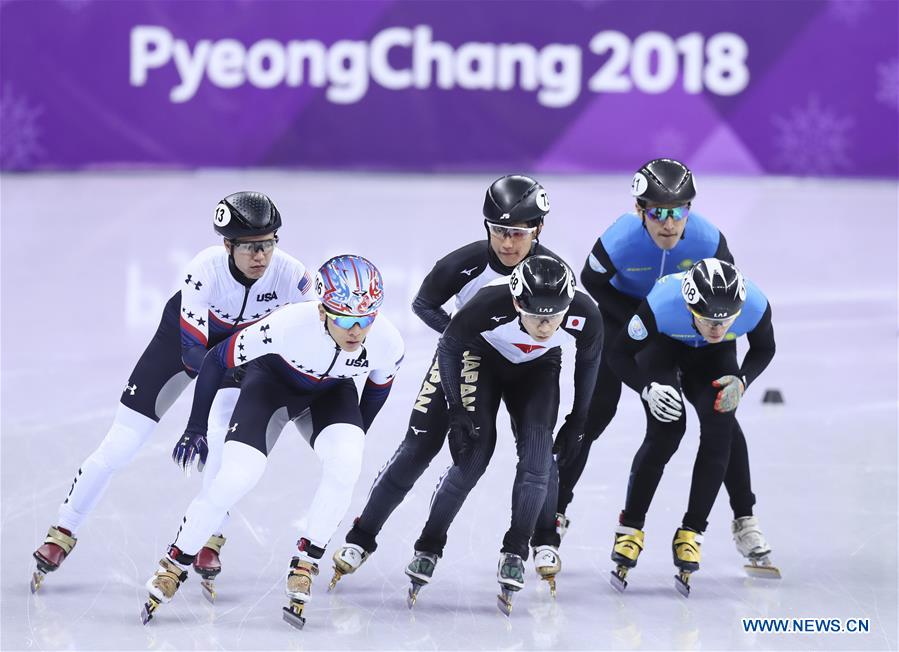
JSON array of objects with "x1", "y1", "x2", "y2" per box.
[{"x1": 142, "y1": 255, "x2": 403, "y2": 628}]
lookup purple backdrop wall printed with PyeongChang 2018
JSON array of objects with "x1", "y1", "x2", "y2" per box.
[{"x1": 0, "y1": 0, "x2": 899, "y2": 177}]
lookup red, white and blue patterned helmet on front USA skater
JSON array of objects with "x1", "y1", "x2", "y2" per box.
[{"x1": 315, "y1": 254, "x2": 384, "y2": 316}]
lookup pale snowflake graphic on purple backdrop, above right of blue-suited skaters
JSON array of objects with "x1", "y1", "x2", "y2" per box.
[{"x1": 772, "y1": 95, "x2": 855, "y2": 175}]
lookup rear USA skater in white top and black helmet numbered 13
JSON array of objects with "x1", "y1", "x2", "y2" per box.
[{"x1": 31, "y1": 192, "x2": 312, "y2": 592}]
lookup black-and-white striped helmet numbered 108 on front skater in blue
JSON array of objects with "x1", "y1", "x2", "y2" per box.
[{"x1": 681, "y1": 258, "x2": 746, "y2": 319}]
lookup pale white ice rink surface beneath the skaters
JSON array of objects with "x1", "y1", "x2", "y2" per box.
[{"x1": 0, "y1": 171, "x2": 899, "y2": 650}]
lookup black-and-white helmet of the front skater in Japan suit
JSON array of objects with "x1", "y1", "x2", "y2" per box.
[{"x1": 509, "y1": 255, "x2": 574, "y2": 315}]
